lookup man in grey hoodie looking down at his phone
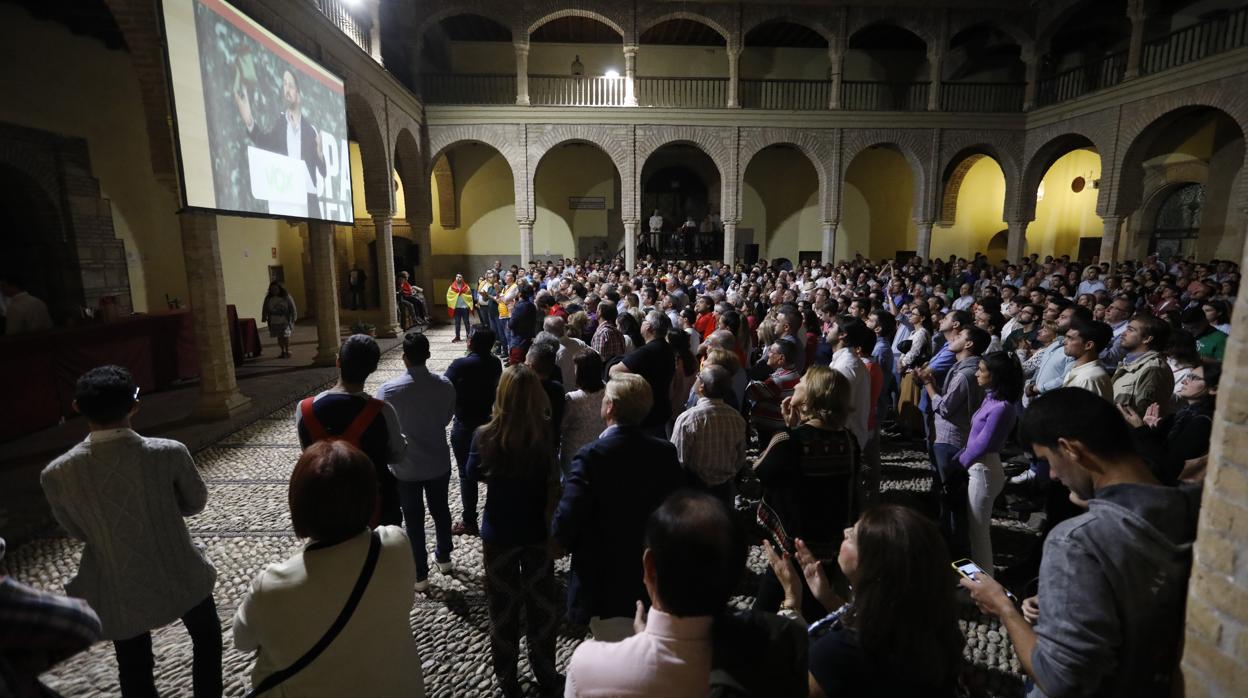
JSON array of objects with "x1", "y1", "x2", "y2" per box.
[{"x1": 961, "y1": 388, "x2": 1199, "y2": 698}]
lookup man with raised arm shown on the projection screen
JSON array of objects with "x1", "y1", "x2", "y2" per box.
[{"x1": 235, "y1": 69, "x2": 326, "y2": 217}]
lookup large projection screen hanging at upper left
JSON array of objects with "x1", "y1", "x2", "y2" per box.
[{"x1": 161, "y1": 0, "x2": 354, "y2": 224}]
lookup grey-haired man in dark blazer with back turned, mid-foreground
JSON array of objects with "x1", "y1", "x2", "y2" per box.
[{"x1": 552, "y1": 373, "x2": 691, "y2": 642}]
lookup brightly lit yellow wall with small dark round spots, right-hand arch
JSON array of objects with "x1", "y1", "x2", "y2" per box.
[{"x1": 1027, "y1": 150, "x2": 1104, "y2": 257}]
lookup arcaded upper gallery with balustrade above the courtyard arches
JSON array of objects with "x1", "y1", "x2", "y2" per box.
[{"x1": 411, "y1": 0, "x2": 1248, "y2": 112}]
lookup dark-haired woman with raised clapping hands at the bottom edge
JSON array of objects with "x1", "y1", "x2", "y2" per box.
[{"x1": 764, "y1": 504, "x2": 966, "y2": 698}]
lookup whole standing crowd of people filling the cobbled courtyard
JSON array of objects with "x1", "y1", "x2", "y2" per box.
[{"x1": 0, "y1": 250, "x2": 1239, "y2": 697}]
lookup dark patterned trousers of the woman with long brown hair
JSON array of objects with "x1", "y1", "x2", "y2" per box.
[{"x1": 482, "y1": 542, "x2": 563, "y2": 696}]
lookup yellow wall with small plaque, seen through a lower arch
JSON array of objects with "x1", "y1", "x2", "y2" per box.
[{"x1": 533, "y1": 145, "x2": 619, "y2": 257}]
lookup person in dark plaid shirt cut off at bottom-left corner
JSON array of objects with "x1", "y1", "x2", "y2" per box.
[{"x1": 0, "y1": 538, "x2": 100, "y2": 696}]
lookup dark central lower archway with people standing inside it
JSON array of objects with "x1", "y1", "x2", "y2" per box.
[{"x1": 638, "y1": 141, "x2": 724, "y2": 260}]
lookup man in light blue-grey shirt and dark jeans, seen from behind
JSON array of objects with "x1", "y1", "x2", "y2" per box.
[{"x1": 377, "y1": 331, "x2": 461, "y2": 591}]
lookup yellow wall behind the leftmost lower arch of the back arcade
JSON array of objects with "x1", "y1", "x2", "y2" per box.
[{"x1": 429, "y1": 144, "x2": 519, "y2": 255}]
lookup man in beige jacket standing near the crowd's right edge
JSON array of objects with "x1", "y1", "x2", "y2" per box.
[{"x1": 1113, "y1": 313, "x2": 1174, "y2": 415}]
